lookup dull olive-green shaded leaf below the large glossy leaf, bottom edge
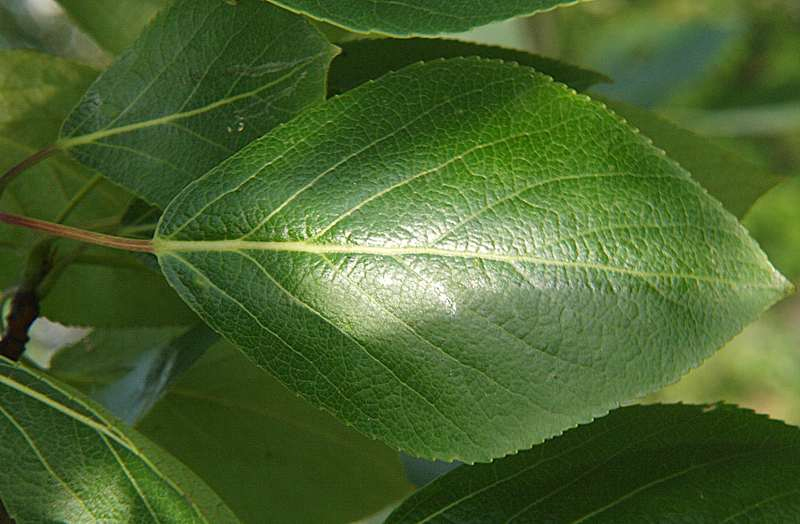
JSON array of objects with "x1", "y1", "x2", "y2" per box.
[{"x1": 139, "y1": 344, "x2": 409, "y2": 524}]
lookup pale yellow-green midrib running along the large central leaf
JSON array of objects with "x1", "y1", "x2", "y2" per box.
[{"x1": 153, "y1": 238, "x2": 783, "y2": 289}]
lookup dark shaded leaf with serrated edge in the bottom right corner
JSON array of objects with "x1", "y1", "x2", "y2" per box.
[{"x1": 386, "y1": 405, "x2": 800, "y2": 524}]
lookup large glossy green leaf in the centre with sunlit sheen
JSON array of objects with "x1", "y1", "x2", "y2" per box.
[{"x1": 154, "y1": 59, "x2": 791, "y2": 461}]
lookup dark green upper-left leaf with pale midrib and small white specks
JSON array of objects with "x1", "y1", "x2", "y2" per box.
[{"x1": 59, "y1": 0, "x2": 335, "y2": 208}]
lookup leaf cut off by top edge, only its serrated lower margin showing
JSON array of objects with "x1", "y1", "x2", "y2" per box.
[{"x1": 268, "y1": 0, "x2": 582, "y2": 36}]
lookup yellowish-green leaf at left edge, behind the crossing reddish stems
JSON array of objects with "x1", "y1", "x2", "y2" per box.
[{"x1": 0, "y1": 51, "x2": 129, "y2": 294}]
